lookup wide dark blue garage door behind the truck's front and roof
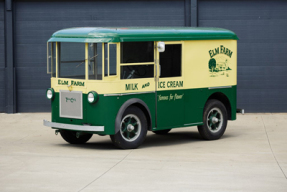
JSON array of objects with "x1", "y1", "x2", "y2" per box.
[{"x1": 15, "y1": 0, "x2": 184, "y2": 112}]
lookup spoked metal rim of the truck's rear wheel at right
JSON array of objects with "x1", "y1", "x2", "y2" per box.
[{"x1": 206, "y1": 108, "x2": 223, "y2": 133}]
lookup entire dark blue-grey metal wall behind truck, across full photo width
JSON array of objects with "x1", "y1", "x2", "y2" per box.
[{"x1": 0, "y1": 0, "x2": 287, "y2": 112}]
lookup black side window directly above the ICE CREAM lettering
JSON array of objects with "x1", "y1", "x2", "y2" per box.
[{"x1": 159, "y1": 44, "x2": 182, "y2": 77}]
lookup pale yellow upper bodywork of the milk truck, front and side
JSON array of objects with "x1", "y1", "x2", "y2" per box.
[{"x1": 51, "y1": 40, "x2": 237, "y2": 94}]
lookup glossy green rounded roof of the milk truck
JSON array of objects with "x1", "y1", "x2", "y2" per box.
[{"x1": 48, "y1": 27, "x2": 238, "y2": 43}]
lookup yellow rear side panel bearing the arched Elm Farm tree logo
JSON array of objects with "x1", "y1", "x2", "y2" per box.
[{"x1": 183, "y1": 40, "x2": 237, "y2": 89}]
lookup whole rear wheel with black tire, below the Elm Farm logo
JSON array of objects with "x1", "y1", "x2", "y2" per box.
[{"x1": 198, "y1": 99, "x2": 227, "y2": 140}]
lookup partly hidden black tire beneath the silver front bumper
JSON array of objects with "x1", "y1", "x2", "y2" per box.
[{"x1": 60, "y1": 130, "x2": 93, "y2": 144}]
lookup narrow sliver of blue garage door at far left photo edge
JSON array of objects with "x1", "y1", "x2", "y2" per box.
[{"x1": 0, "y1": 0, "x2": 5, "y2": 112}]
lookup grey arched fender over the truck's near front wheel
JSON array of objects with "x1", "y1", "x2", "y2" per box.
[{"x1": 115, "y1": 98, "x2": 152, "y2": 134}]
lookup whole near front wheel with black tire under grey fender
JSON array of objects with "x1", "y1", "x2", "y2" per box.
[{"x1": 110, "y1": 106, "x2": 147, "y2": 149}]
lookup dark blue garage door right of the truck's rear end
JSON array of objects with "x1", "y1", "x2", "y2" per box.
[{"x1": 198, "y1": 0, "x2": 287, "y2": 112}]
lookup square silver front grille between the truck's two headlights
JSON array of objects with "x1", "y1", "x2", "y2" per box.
[{"x1": 60, "y1": 90, "x2": 83, "y2": 119}]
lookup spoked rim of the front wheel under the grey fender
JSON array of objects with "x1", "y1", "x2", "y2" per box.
[{"x1": 120, "y1": 114, "x2": 141, "y2": 142}]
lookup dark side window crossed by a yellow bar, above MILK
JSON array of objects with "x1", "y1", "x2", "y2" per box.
[{"x1": 120, "y1": 41, "x2": 154, "y2": 79}]
